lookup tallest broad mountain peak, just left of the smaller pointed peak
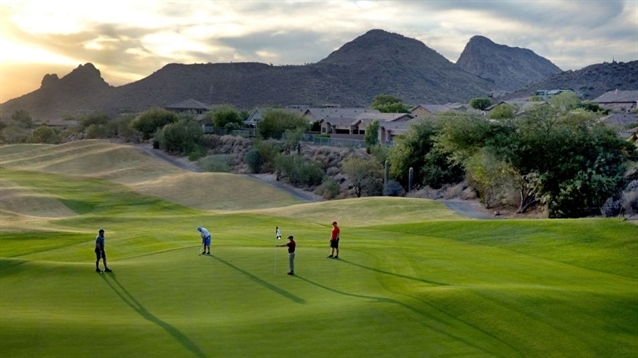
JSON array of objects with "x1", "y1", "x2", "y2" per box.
[{"x1": 314, "y1": 30, "x2": 494, "y2": 104}]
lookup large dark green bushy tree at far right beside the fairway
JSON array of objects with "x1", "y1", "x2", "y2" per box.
[{"x1": 517, "y1": 107, "x2": 635, "y2": 217}]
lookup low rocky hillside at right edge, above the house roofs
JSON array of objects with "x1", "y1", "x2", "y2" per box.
[{"x1": 505, "y1": 61, "x2": 638, "y2": 99}]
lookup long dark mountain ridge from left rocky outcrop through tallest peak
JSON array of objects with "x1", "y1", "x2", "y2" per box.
[{"x1": 0, "y1": 30, "x2": 494, "y2": 119}]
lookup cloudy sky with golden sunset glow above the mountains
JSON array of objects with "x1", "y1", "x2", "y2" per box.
[{"x1": 0, "y1": 0, "x2": 638, "y2": 103}]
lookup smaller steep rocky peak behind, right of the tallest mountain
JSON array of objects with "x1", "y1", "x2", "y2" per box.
[{"x1": 456, "y1": 36, "x2": 561, "y2": 91}]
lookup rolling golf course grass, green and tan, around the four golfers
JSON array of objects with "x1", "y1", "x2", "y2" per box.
[{"x1": 0, "y1": 140, "x2": 638, "y2": 358}]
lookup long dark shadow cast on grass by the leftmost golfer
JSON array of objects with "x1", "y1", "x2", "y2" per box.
[{"x1": 100, "y1": 272, "x2": 206, "y2": 357}]
